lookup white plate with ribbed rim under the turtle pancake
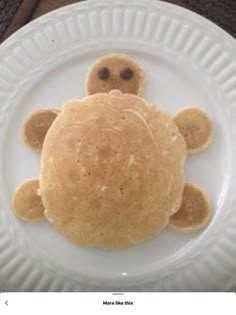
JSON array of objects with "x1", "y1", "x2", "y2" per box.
[{"x1": 0, "y1": 0, "x2": 236, "y2": 291}]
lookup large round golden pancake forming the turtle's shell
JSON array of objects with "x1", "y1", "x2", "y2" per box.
[{"x1": 40, "y1": 91, "x2": 186, "y2": 248}]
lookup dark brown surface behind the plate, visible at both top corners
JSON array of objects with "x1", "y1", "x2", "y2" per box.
[{"x1": 0, "y1": 0, "x2": 236, "y2": 42}]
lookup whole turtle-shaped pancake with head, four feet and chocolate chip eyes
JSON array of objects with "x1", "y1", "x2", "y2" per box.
[{"x1": 12, "y1": 54, "x2": 212, "y2": 248}]
